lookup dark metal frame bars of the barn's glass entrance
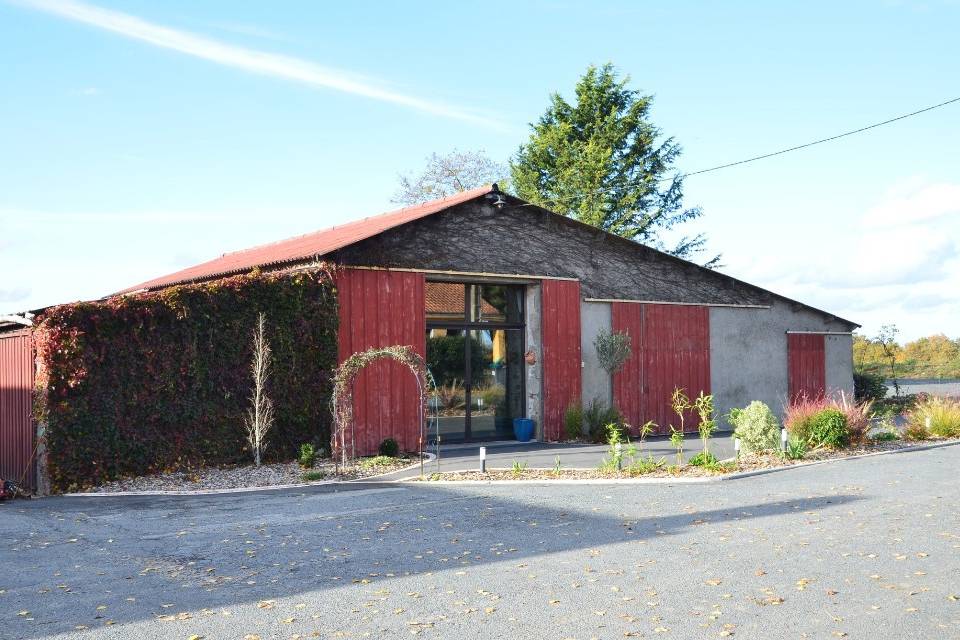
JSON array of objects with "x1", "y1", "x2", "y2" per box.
[{"x1": 426, "y1": 277, "x2": 530, "y2": 442}]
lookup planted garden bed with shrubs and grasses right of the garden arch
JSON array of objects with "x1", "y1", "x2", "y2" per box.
[{"x1": 417, "y1": 389, "x2": 960, "y2": 481}]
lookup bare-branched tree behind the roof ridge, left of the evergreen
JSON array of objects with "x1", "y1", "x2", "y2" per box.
[{"x1": 393, "y1": 149, "x2": 509, "y2": 205}]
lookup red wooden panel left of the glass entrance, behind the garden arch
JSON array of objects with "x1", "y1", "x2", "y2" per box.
[{"x1": 337, "y1": 269, "x2": 427, "y2": 455}]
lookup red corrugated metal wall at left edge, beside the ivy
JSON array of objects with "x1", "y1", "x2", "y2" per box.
[{"x1": 0, "y1": 330, "x2": 35, "y2": 489}]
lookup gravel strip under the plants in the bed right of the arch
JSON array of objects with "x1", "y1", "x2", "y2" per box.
[{"x1": 411, "y1": 438, "x2": 956, "y2": 482}]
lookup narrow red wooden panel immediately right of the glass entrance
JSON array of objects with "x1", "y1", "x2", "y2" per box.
[{"x1": 540, "y1": 280, "x2": 581, "y2": 440}]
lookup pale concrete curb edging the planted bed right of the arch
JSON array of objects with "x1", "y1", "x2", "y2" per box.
[{"x1": 392, "y1": 440, "x2": 960, "y2": 486}]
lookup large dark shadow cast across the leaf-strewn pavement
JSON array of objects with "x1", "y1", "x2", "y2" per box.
[{"x1": 0, "y1": 484, "x2": 861, "y2": 638}]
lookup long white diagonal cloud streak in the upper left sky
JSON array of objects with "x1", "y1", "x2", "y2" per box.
[{"x1": 16, "y1": 0, "x2": 504, "y2": 129}]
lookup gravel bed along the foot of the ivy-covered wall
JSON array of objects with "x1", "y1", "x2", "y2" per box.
[{"x1": 84, "y1": 456, "x2": 416, "y2": 493}]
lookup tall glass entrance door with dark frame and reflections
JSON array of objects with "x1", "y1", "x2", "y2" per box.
[{"x1": 426, "y1": 282, "x2": 525, "y2": 442}]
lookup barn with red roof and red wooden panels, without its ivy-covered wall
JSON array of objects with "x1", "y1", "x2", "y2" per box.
[{"x1": 0, "y1": 185, "x2": 858, "y2": 488}]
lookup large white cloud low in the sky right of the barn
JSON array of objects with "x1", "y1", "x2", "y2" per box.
[{"x1": 724, "y1": 179, "x2": 960, "y2": 339}]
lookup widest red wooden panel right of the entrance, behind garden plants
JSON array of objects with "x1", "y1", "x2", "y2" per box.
[{"x1": 611, "y1": 302, "x2": 710, "y2": 433}]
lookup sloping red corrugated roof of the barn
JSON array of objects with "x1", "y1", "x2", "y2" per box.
[{"x1": 118, "y1": 185, "x2": 493, "y2": 293}]
